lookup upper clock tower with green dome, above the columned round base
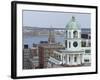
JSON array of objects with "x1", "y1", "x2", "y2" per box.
[{"x1": 65, "y1": 16, "x2": 81, "y2": 51}]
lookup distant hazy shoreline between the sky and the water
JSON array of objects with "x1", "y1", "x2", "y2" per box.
[{"x1": 22, "y1": 27, "x2": 91, "y2": 36}]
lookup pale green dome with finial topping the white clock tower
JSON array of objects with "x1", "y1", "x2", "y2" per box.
[{"x1": 66, "y1": 16, "x2": 80, "y2": 30}]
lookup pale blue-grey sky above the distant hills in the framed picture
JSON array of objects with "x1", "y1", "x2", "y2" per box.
[{"x1": 23, "y1": 10, "x2": 91, "y2": 28}]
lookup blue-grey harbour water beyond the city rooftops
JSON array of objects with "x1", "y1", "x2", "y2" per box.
[{"x1": 22, "y1": 35, "x2": 64, "y2": 48}]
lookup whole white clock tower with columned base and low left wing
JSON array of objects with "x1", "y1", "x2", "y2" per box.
[{"x1": 49, "y1": 16, "x2": 85, "y2": 66}]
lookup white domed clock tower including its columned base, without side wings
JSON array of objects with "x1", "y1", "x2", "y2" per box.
[{"x1": 65, "y1": 16, "x2": 84, "y2": 65}]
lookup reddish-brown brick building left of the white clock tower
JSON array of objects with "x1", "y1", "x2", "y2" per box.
[{"x1": 38, "y1": 44, "x2": 64, "y2": 68}]
